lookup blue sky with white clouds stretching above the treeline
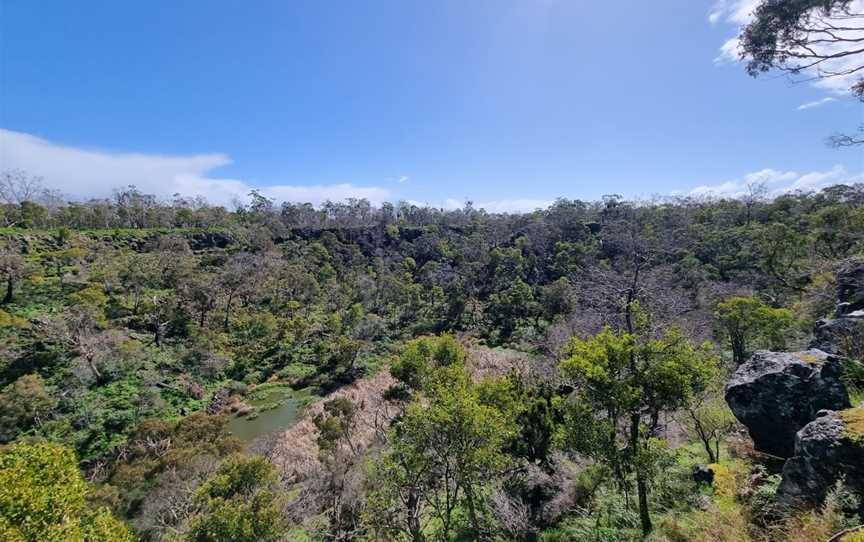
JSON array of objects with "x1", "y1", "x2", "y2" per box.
[{"x1": 0, "y1": 0, "x2": 864, "y2": 210}]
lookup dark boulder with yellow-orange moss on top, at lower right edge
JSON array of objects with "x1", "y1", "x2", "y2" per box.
[{"x1": 777, "y1": 408, "x2": 864, "y2": 506}]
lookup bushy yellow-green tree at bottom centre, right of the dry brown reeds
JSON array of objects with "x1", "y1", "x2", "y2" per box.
[{"x1": 369, "y1": 336, "x2": 519, "y2": 540}]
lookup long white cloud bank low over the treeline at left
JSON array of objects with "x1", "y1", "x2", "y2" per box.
[{"x1": 0, "y1": 128, "x2": 390, "y2": 205}]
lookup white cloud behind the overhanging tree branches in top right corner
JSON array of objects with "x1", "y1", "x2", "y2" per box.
[{"x1": 708, "y1": 0, "x2": 864, "y2": 95}]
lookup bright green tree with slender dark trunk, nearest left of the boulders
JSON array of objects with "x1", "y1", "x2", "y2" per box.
[{"x1": 562, "y1": 318, "x2": 717, "y2": 535}]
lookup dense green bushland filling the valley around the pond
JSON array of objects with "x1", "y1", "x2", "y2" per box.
[{"x1": 0, "y1": 177, "x2": 864, "y2": 541}]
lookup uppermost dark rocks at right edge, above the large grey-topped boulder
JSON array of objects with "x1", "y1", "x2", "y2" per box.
[{"x1": 810, "y1": 262, "x2": 864, "y2": 354}]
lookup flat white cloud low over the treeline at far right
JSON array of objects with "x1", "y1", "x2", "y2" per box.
[{"x1": 689, "y1": 166, "x2": 864, "y2": 198}]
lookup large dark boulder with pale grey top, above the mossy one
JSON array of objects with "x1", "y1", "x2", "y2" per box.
[{"x1": 726, "y1": 350, "x2": 850, "y2": 458}]
